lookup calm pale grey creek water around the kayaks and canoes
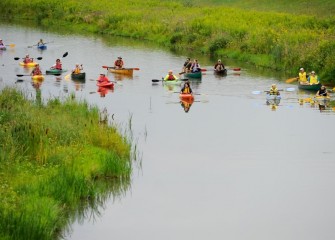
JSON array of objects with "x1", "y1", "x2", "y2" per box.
[{"x1": 0, "y1": 24, "x2": 335, "y2": 240}]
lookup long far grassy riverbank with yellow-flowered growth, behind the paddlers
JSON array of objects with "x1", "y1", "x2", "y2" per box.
[{"x1": 0, "y1": 0, "x2": 335, "y2": 84}]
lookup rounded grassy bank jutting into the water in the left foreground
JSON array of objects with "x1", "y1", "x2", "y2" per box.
[{"x1": 0, "y1": 89, "x2": 132, "y2": 239}]
